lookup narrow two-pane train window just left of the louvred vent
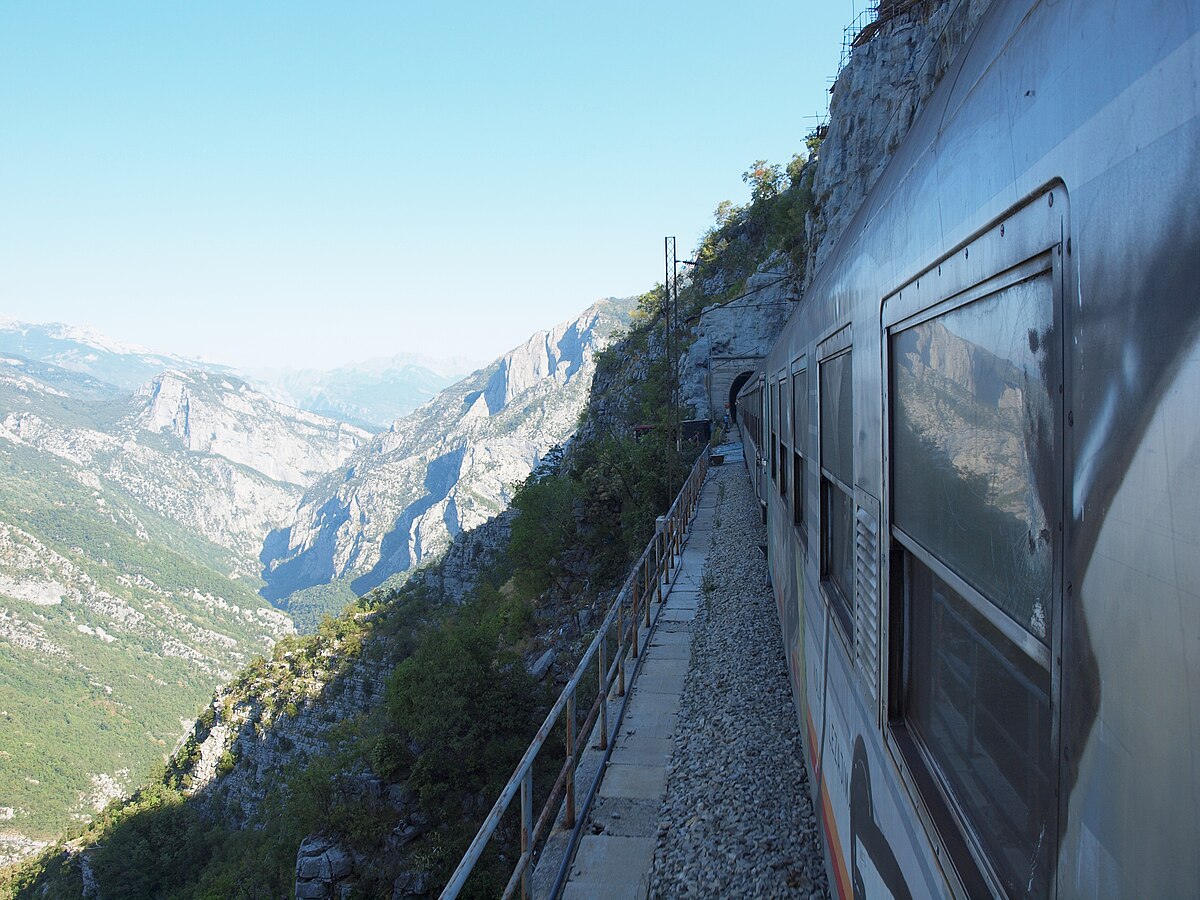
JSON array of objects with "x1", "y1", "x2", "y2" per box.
[{"x1": 820, "y1": 350, "x2": 854, "y2": 635}]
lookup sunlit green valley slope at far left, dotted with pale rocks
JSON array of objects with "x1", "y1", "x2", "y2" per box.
[{"x1": 0, "y1": 443, "x2": 280, "y2": 838}]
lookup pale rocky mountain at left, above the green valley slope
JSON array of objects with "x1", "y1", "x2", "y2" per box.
[{"x1": 0, "y1": 358, "x2": 370, "y2": 566}]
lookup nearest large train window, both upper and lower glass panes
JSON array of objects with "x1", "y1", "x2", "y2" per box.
[{"x1": 890, "y1": 275, "x2": 1062, "y2": 896}]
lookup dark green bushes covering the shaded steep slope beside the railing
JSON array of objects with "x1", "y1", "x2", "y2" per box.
[{"x1": 0, "y1": 146, "x2": 814, "y2": 898}]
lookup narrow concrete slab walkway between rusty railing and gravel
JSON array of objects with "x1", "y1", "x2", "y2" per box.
[{"x1": 563, "y1": 475, "x2": 715, "y2": 900}]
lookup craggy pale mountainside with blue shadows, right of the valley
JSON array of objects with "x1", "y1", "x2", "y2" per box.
[{"x1": 263, "y1": 301, "x2": 628, "y2": 600}]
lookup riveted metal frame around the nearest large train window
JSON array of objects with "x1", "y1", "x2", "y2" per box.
[{"x1": 880, "y1": 192, "x2": 1072, "y2": 895}]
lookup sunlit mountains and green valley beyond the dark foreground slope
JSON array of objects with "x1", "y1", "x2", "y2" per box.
[{"x1": 0, "y1": 301, "x2": 630, "y2": 864}]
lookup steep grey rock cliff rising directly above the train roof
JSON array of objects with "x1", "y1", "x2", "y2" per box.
[{"x1": 805, "y1": 0, "x2": 991, "y2": 286}]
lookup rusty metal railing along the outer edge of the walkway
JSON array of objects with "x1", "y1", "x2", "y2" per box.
[{"x1": 440, "y1": 449, "x2": 708, "y2": 900}]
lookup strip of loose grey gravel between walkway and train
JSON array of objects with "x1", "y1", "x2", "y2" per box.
[{"x1": 650, "y1": 466, "x2": 829, "y2": 898}]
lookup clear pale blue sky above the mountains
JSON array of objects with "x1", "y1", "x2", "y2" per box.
[{"x1": 0, "y1": 0, "x2": 864, "y2": 366}]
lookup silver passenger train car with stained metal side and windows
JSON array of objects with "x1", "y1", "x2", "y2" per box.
[{"x1": 738, "y1": 0, "x2": 1200, "y2": 898}]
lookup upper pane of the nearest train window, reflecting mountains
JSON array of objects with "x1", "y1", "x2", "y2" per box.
[{"x1": 892, "y1": 276, "x2": 1058, "y2": 642}]
